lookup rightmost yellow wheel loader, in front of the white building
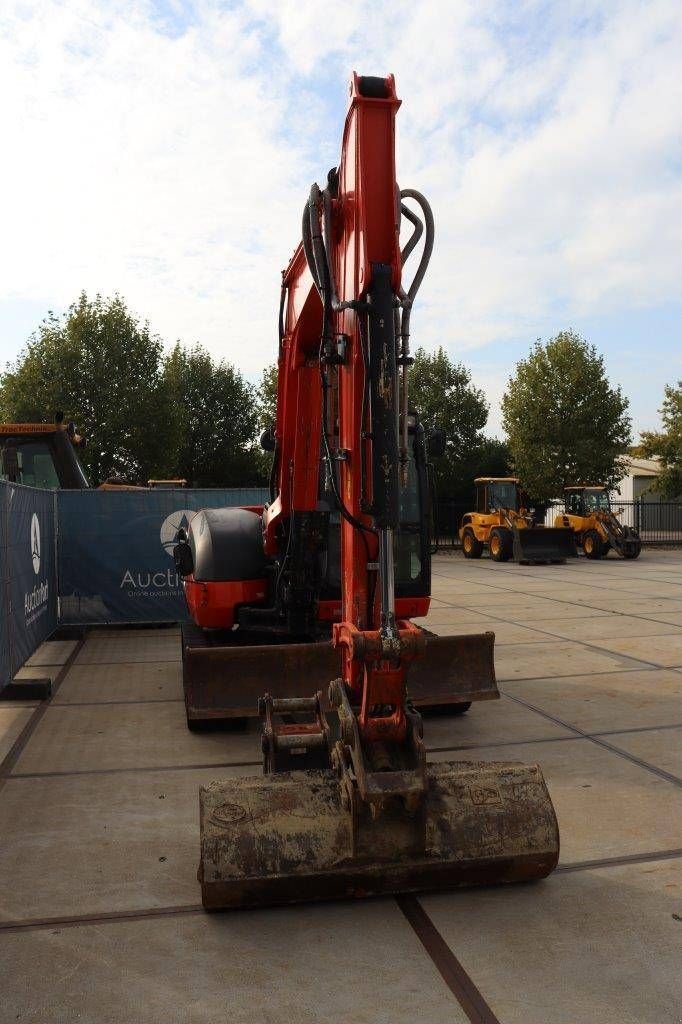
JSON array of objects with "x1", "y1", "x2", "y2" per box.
[{"x1": 554, "y1": 484, "x2": 642, "y2": 558}]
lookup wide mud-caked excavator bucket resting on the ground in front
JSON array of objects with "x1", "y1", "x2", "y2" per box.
[{"x1": 199, "y1": 762, "x2": 559, "y2": 910}]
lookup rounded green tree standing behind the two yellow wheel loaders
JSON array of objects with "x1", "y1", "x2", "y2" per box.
[{"x1": 502, "y1": 331, "x2": 632, "y2": 501}]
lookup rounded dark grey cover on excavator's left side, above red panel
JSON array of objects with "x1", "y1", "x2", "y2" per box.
[{"x1": 187, "y1": 508, "x2": 267, "y2": 583}]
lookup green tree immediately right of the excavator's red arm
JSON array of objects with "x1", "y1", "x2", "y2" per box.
[{"x1": 410, "y1": 347, "x2": 491, "y2": 501}]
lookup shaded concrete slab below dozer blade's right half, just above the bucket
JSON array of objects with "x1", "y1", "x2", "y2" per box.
[{"x1": 423, "y1": 692, "x2": 573, "y2": 757}]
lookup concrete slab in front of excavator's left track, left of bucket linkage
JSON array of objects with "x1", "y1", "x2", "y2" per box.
[{"x1": 14, "y1": 703, "x2": 261, "y2": 774}]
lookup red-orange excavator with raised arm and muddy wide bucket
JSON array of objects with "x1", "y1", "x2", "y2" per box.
[{"x1": 175, "y1": 75, "x2": 558, "y2": 909}]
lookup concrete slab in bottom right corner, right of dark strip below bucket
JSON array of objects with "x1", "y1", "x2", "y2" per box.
[{"x1": 422, "y1": 860, "x2": 682, "y2": 1024}]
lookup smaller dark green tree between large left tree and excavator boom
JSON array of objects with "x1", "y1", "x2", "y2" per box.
[{"x1": 164, "y1": 342, "x2": 261, "y2": 487}]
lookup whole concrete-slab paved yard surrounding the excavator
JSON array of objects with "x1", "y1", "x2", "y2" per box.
[{"x1": 0, "y1": 550, "x2": 682, "y2": 1024}]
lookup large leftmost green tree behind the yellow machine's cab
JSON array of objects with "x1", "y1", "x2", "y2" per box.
[{"x1": 0, "y1": 292, "x2": 174, "y2": 485}]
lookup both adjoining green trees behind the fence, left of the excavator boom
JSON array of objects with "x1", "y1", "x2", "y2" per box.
[{"x1": 0, "y1": 293, "x2": 266, "y2": 486}]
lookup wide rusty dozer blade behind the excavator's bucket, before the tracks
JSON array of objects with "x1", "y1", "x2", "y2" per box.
[{"x1": 182, "y1": 627, "x2": 500, "y2": 724}]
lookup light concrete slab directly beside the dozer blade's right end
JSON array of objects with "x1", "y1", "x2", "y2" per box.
[{"x1": 495, "y1": 639, "x2": 629, "y2": 682}]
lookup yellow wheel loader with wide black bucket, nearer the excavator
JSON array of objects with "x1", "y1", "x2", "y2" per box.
[{"x1": 459, "y1": 476, "x2": 578, "y2": 564}]
